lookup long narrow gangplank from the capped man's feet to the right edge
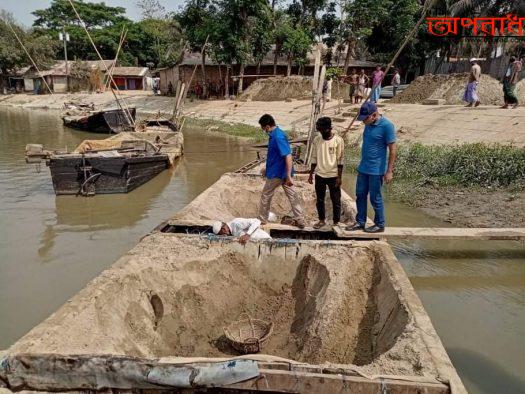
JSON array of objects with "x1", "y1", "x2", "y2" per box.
[{"x1": 334, "y1": 227, "x2": 525, "y2": 241}]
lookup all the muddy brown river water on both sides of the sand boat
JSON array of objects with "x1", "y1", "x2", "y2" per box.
[{"x1": 0, "y1": 108, "x2": 525, "y2": 393}]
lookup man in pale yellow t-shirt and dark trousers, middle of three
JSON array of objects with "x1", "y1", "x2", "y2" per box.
[{"x1": 308, "y1": 117, "x2": 345, "y2": 229}]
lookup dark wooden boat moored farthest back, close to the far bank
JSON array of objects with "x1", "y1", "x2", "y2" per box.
[{"x1": 62, "y1": 108, "x2": 136, "y2": 134}]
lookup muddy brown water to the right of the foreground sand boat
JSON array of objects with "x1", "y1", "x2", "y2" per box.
[{"x1": 344, "y1": 172, "x2": 525, "y2": 393}]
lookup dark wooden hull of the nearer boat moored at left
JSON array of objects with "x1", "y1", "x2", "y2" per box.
[{"x1": 48, "y1": 155, "x2": 169, "y2": 195}]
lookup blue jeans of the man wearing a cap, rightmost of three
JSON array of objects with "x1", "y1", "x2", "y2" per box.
[{"x1": 355, "y1": 172, "x2": 385, "y2": 227}]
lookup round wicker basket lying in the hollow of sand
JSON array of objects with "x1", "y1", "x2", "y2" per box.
[{"x1": 224, "y1": 313, "x2": 273, "y2": 354}]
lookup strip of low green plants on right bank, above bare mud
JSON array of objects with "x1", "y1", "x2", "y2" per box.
[{"x1": 347, "y1": 143, "x2": 525, "y2": 187}]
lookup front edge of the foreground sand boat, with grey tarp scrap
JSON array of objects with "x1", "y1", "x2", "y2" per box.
[{"x1": 0, "y1": 354, "x2": 450, "y2": 394}]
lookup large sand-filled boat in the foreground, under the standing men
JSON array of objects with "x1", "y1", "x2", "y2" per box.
[{"x1": 0, "y1": 174, "x2": 465, "y2": 393}]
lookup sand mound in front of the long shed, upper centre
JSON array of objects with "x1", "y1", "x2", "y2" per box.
[{"x1": 239, "y1": 75, "x2": 348, "y2": 101}]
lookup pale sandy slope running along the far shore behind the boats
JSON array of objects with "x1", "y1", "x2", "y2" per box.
[{"x1": 0, "y1": 91, "x2": 525, "y2": 146}]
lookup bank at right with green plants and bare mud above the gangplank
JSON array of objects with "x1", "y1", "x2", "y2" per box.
[{"x1": 347, "y1": 143, "x2": 525, "y2": 227}]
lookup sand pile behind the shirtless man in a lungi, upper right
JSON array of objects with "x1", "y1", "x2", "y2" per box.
[{"x1": 391, "y1": 73, "x2": 502, "y2": 105}]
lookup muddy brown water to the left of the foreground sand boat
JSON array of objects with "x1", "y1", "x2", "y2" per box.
[{"x1": 0, "y1": 108, "x2": 254, "y2": 349}]
